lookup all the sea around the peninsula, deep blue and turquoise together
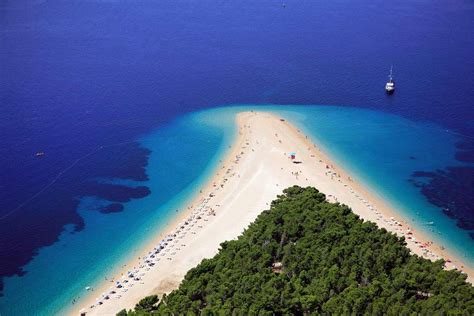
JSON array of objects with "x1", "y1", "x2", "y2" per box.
[{"x1": 0, "y1": 0, "x2": 474, "y2": 315}]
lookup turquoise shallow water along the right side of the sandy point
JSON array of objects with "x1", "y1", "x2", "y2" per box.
[{"x1": 270, "y1": 106, "x2": 474, "y2": 265}]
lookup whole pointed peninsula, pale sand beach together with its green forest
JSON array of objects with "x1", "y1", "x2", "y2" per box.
[{"x1": 68, "y1": 111, "x2": 474, "y2": 315}]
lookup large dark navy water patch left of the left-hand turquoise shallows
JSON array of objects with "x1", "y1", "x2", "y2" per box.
[{"x1": 0, "y1": 142, "x2": 150, "y2": 295}]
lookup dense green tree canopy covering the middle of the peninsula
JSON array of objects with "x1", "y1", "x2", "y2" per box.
[{"x1": 123, "y1": 186, "x2": 474, "y2": 316}]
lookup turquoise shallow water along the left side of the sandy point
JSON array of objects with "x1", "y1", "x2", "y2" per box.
[{"x1": 0, "y1": 109, "x2": 235, "y2": 315}]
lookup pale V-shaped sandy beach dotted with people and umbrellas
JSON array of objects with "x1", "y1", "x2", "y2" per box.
[{"x1": 71, "y1": 112, "x2": 474, "y2": 315}]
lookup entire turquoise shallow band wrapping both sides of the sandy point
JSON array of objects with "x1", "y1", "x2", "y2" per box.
[{"x1": 0, "y1": 105, "x2": 474, "y2": 315}]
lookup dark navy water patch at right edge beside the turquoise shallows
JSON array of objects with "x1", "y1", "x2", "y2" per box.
[{"x1": 413, "y1": 167, "x2": 474, "y2": 232}]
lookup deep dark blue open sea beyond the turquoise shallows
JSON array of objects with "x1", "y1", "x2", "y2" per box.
[{"x1": 0, "y1": 0, "x2": 474, "y2": 312}]
